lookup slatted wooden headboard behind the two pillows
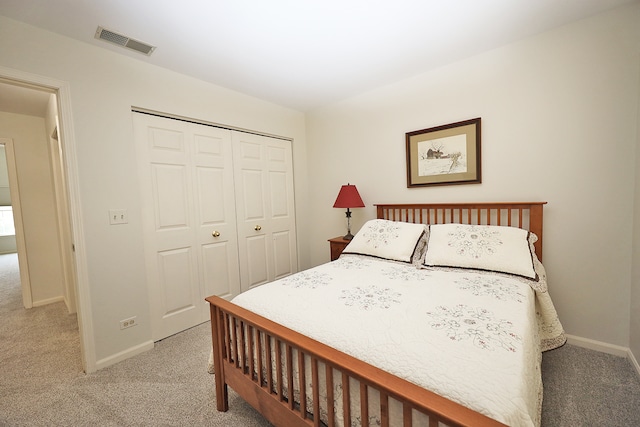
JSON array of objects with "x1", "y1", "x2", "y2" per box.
[{"x1": 375, "y1": 202, "x2": 547, "y2": 261}]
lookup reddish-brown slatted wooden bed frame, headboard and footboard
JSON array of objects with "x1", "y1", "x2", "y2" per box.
[{"x1": 206, "y1": 202, "x2": 546, "y2": 427}]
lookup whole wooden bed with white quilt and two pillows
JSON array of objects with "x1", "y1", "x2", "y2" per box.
[{"x1": 206, "y1": 202, "x2": 565, "y2": 427}]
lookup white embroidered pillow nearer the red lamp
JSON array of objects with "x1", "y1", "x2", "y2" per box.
[{"x1": 342, "y1": 219, "x2": 427, "y2": 262}]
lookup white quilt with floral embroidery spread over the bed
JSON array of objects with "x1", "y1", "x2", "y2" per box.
[{"x1": 233, "y1": 255, "x2": 564, "y2": 426}]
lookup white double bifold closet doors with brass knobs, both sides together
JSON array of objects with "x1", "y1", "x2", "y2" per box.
[{"x1": 132, "y1": 112, "x2": 297, "y2": 341}]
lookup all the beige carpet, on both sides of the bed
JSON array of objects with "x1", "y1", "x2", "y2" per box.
[{"x1": 0, "y1": 255, "x2": 640, "y2": 427}]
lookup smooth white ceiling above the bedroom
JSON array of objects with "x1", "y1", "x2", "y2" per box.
[{"x1": 0, "y1": 0, "x2": 637, "y2": 111}]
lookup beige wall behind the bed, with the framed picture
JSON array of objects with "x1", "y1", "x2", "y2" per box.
[{"x1": 307, "y1": 4, "x2": 640, "y2": 356}]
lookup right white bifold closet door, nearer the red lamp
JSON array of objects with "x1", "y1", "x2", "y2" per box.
[{"x1": 232, "y1": 132, "x2": 298, "y2": 291}]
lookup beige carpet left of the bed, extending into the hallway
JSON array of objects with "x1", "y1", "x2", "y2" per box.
[{"x1": 0, "y1": 255, "x2": 270, "y2": 427}]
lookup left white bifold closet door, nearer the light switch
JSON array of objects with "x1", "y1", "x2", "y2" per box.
[{"x1": 133, "y1": 113, "x2": 240, "y2": 341}]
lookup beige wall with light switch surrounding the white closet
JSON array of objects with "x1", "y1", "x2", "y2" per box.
[{"x1": 0, "y1": 13, "x2": 310, "y2": 370}]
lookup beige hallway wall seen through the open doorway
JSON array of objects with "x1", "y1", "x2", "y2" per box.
[{"x1": 0, "y1": 112, "x2": 63, "y2": 306}]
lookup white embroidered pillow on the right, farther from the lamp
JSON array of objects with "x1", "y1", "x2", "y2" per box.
[{"x1": 424, "y1": 224, "x2": 537, "y2": 279}]
